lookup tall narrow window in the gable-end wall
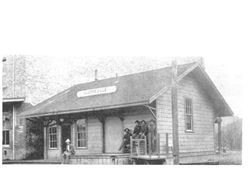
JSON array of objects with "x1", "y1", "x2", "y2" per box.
[{"x1": 185, "y1": 98, "x2": 193, "y2": 131}]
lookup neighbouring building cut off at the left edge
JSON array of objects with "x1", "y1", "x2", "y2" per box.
[{"x1": 2, "y1": 56, "x2": 31, "y2": 160}]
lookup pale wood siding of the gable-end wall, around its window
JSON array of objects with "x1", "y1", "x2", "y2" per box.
[{"x1": 156, "y1": 76, "x2": 215, "y2": 153}]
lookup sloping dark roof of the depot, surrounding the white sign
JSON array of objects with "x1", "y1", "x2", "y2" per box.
[{"x1": 22, "y1": 63, "x2": 232, "y2": 117}]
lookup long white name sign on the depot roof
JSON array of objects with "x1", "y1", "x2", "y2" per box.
[{"x1": 77, "y1": 86, "x2": 117, "y2": 98}]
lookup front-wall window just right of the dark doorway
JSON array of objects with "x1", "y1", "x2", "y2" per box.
[{"x1": 77, "y1": 119, "x2": 87, "y2": 148}]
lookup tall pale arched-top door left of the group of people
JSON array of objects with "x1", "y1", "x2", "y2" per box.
[{"x1": 105, "y1": 117, "x2": 123, "y2": 153}]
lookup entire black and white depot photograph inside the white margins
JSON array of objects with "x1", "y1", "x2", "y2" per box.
[{"x1": 2, "y1": 55, "x2": 242, "y2": 165}]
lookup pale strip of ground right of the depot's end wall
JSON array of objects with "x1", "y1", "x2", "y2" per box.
[{"x1": 219, "y1": 151, "x2": 242, "y2": 165}]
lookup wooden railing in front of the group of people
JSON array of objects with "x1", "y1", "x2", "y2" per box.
[{"x1": 130, "y1": 133, "x2": 169, "y2": 157}]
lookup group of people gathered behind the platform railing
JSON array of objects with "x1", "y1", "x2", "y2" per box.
[{"x1": 119, "y1": 120, "x2": 156, "y2": 153}]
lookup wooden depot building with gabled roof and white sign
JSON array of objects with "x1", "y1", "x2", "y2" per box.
[{"x1": 20, "y1": 63, "x2": 233, "y2": 164}]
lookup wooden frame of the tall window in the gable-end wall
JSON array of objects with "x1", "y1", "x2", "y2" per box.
[{"x1": 184, "y1": 97, "x2": 194, "y2": 133}]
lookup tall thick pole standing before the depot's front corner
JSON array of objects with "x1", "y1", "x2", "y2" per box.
[{"x1": 171, "y1": 61, "x2": 179, "y2": 165}]
